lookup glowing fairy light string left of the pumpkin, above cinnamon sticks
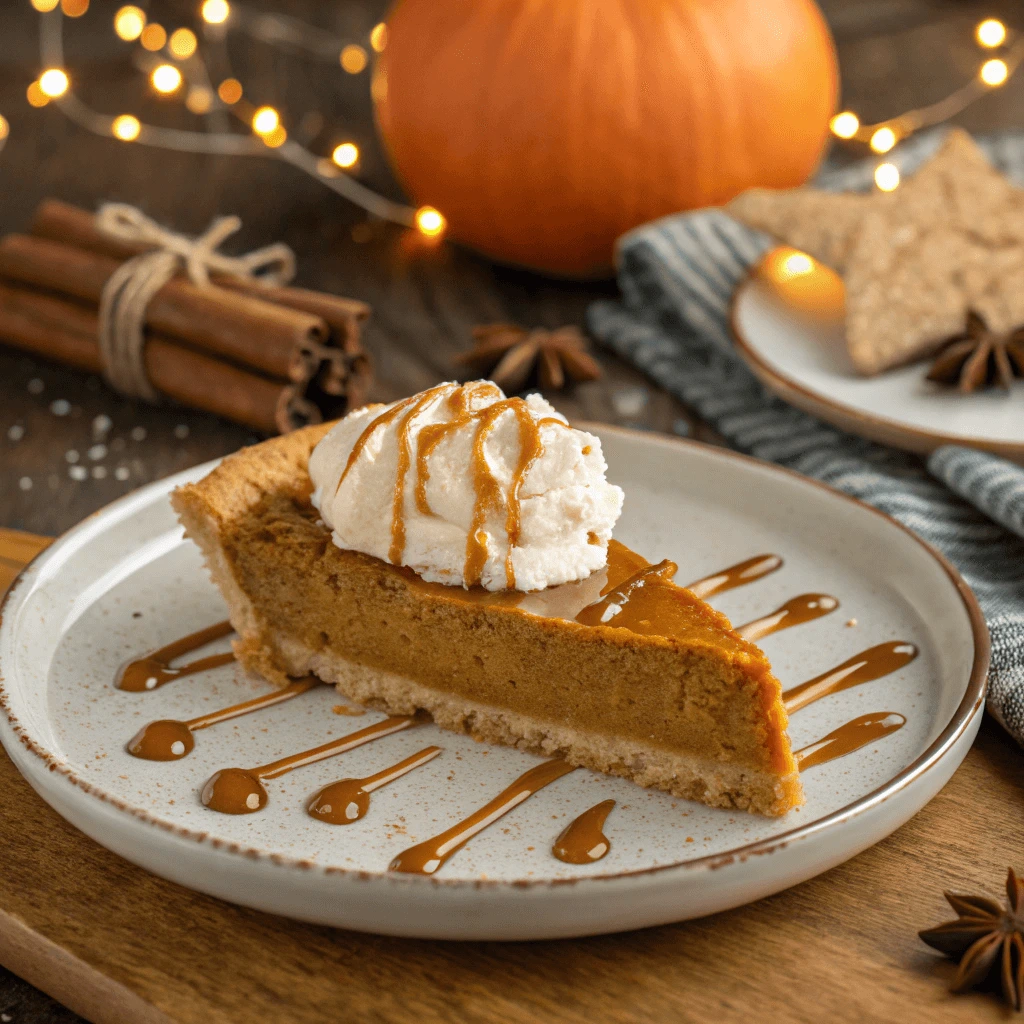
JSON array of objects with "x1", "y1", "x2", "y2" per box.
[{"x1": 9, "y1": 0, "x2": 447, "y2": 239}]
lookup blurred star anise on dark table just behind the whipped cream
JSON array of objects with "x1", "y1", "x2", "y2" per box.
[{"x1": 455, "y1": 324, "x2": 601, "y2": 394}]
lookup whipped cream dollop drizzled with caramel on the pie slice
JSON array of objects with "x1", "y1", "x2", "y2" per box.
[{"x1": 309, "y1": 381, "x2": 623, "y2": 591}]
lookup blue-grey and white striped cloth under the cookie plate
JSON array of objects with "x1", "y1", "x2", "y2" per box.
[{"x1": 588, "y1": 135, "x2": 1024, "y2": 743}]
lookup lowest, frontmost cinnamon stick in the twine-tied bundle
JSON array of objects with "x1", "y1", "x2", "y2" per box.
[{"x1": 0, "y1": 283, "x2": 280, "y2": 433}]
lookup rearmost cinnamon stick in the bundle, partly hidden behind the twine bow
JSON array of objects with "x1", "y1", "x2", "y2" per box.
[{"x1": 30, "y1": 199, "x2": 370, "y2": 344}]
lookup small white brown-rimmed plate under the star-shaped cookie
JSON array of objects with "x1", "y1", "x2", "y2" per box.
[{"x1": 732, "y1": 254, "x2": 1024, "y2": 462}]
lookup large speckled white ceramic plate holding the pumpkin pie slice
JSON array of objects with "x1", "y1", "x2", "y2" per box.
[{"x1": 0, "y1": 427, "x2": 988, "y2": 939}]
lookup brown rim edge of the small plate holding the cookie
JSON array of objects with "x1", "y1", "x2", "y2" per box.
[{"x1": 729, "y1": 260, "x2": 1024, "y2": 462}]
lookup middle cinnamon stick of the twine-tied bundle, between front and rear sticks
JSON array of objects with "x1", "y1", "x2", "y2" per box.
[{"x1": 0, "y1": 234, "x2": 328, "y2": 378}]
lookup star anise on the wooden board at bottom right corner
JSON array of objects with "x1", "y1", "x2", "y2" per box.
[{"x1": 918, "y1": 867, "x2": 1024, "y2": 1011}]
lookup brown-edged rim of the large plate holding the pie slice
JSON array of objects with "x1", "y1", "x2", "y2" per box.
[{"x1": 0, "y1": 432, "x2": 990, "y2": 891}]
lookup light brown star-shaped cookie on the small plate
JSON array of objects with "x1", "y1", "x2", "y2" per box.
[{"x1": 728, "y1": 131, "x2": 1024, "y2": 375}]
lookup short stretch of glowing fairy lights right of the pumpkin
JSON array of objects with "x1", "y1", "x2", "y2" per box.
[{"x1": 830, "y1": 17, "x2": 1024, "y2": 191}]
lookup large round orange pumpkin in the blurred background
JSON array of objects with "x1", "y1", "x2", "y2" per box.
[{"x1": 374, "y1": 0, "x2": 837, "y2": 276}]
